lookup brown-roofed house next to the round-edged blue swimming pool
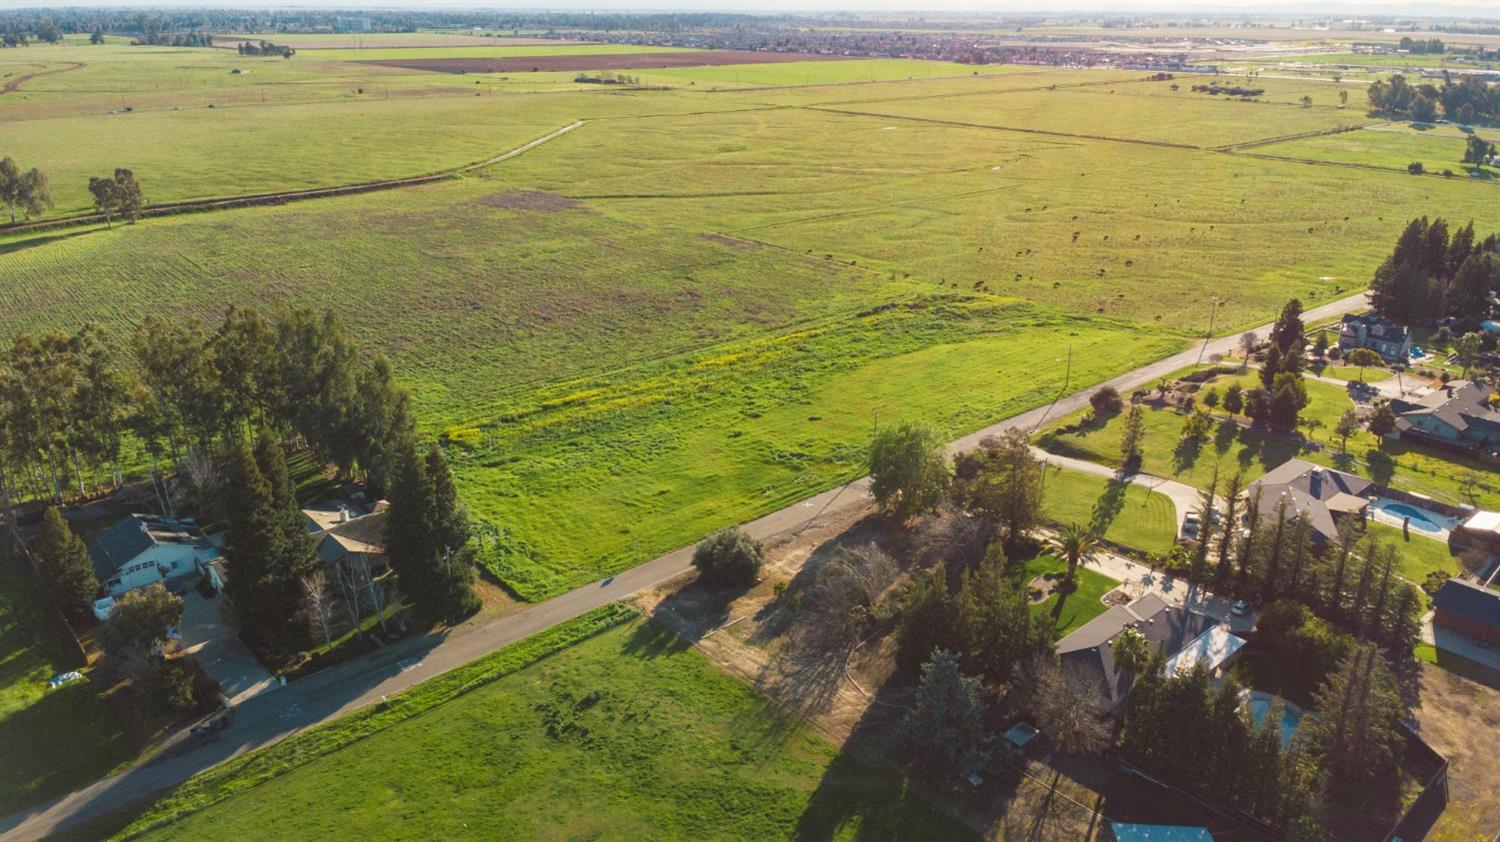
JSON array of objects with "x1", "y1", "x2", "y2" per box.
[{"x1": 1245, "y1": 459, "x2": 1377, "y2": 549}]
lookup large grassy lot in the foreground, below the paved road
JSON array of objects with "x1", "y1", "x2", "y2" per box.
[{"x1": 129, "y1": 609, "x2": 971, "y2": 840}]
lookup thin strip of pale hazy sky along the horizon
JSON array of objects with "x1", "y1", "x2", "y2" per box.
[{"x1": 0, "y1": 0, "x2": 1500, "y2": 15}]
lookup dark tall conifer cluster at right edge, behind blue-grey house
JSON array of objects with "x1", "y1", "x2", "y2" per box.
[{"x1": 1370, "y1": 216, "x2": 1500, "y2": 322}]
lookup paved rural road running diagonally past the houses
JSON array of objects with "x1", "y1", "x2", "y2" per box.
[{"x1": 0, "y1": 286, "x2": 1368, "y2": 839}]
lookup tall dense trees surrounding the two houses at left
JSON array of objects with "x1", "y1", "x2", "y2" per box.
[{"x1": 0, "y1": 308, "x2": 477, "y2": 659}]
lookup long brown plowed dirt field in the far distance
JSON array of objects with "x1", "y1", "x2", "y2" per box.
[{"x1": 360, "y1": 50, "x2": 846, "y2": 74}]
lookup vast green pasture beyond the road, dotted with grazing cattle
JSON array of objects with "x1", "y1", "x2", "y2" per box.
[{"x1": 0, "y1": 47, "x2": 1500, "y2": 599}]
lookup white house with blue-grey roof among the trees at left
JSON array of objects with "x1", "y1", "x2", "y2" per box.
[{"x1": 89, "y1": 515, "x2": 219, "y2": 615}]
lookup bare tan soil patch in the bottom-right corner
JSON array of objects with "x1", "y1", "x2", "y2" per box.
[{"x1": 1415, "y1": 663, "x2": 1500, "y2": 842}]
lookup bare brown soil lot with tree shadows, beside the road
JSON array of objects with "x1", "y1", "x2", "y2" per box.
[{"x1": 633, "y1": 506, "x2": 1097, "y2": 842}]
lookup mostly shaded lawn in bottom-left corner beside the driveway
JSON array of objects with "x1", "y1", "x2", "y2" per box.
[{"x1": 0, "y1": 572, "x2": 134, "y2": 815}]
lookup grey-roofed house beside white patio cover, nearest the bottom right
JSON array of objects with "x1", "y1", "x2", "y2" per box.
[{"x1": 1058, "y1": 593, "x2": 1218, "y2": 710}]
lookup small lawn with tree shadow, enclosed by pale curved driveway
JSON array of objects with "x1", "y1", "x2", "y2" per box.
[{"x1": 1043, "y1": 467, "x2": 1178, "y2": 554}]
